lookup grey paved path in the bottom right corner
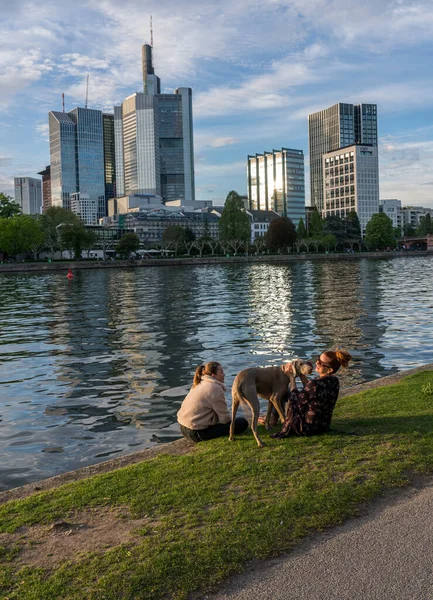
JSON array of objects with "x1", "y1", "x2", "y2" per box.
[{"x1": 204, "y1": 478, "x2": 433, "y2": 600}]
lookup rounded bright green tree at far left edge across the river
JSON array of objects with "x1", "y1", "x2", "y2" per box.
[{"x1": 0, "y1": 214, "x2": 44, "y2": 256}]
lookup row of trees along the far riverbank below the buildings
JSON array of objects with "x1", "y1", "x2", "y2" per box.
[{"x1": 0, "y1": 191, "x2": 433, "y2": 259}]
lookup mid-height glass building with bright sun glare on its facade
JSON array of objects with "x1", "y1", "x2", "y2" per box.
[{"x1": 247, "y1": 148, "x2": 305, "y2": 226}]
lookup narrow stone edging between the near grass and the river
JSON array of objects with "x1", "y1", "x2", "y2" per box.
[{"x1": 0, "y1": 363, "x2": 433, "y2": 504}]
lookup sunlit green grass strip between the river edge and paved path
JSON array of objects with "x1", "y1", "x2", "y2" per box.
[{"x1": 0, "y1": 372, "x2": 433, "y2": 600}]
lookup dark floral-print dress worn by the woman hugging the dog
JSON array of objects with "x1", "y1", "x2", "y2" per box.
[{"x1": 271, "y1": 375, "x2": 340, "y2": 438}]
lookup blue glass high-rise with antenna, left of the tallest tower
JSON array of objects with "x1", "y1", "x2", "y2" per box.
[{"x1": 48, "y1": 108, "x2": 106, "y2": 218}]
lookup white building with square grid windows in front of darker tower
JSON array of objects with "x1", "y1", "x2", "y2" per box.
[{"x1": 322, "y1": 145, "x2": 379, "y2": 236}]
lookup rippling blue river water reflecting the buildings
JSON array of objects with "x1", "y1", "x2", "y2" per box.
[{"x1": 0, "y1": 257, "x2": 433, "y2": 491}]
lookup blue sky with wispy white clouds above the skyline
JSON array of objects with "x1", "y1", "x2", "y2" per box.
[{"x1": 0, "y1": 0, "x2": 433, "y2": 207}]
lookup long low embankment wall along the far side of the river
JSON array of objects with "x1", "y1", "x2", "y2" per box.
[{"x1": 0, "y1": 251, "x2": 433, "y2": 273}]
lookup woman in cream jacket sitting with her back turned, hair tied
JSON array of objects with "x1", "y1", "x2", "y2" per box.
[{"x1": 177, "y1": 362, "x2": 248, "y2": 442}]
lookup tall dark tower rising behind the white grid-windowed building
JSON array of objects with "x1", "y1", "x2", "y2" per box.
[{"x1": 308, "y1": 102, "x2": 377, "y2": 212}]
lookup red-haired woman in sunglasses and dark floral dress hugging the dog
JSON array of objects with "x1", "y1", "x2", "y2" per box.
[{"x1": 271, "y1": 349, "x2": 352, "y2": 438}]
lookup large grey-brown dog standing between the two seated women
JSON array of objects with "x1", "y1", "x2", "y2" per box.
[{"x1": 229, "y1": 358, "x2": 313, "y2": 448}]
